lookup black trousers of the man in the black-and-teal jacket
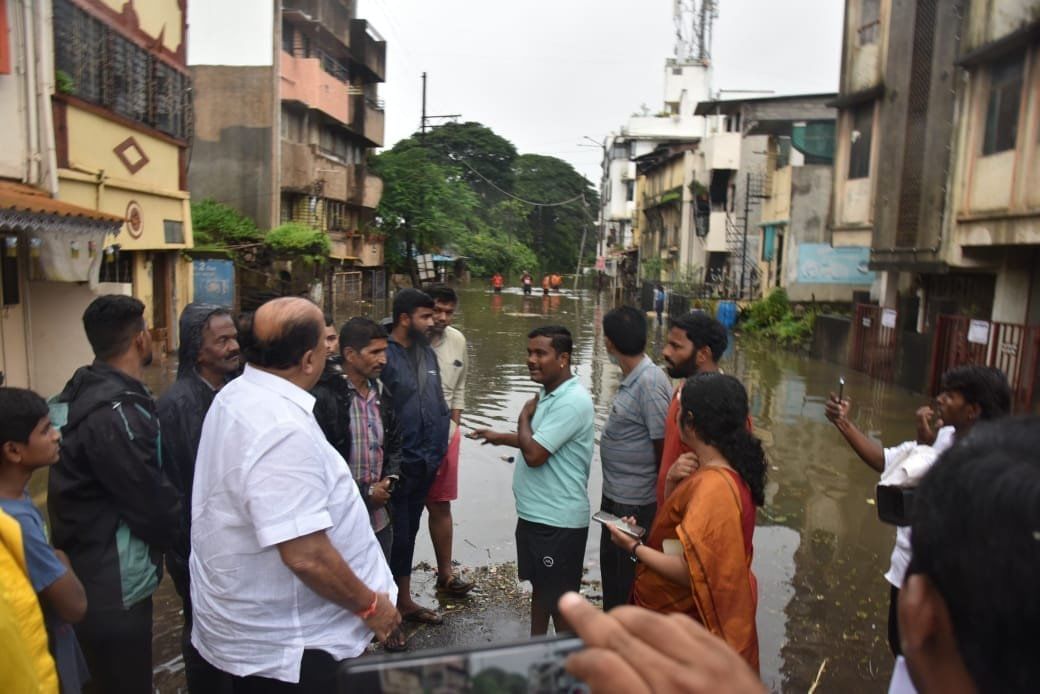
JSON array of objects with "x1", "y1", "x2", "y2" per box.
[{"x1": 74, "y1": 597, "x2": 152, "y2": 694}]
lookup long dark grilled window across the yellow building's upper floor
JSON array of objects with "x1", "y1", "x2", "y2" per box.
[{"x1": 54, "y1": 0, "x2": 191, "y2": 139}]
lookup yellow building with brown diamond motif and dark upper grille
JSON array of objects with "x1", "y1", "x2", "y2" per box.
[{"x1": 48, "y1": 0, "x2": 192, "y2": 349}]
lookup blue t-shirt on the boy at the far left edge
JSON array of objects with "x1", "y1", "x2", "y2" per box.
[{"x1": 0, "y1": 494, "x2": 88, "y2": 694}]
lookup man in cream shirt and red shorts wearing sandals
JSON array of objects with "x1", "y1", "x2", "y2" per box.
[{"x1": 426, "y1": 285, "x2": 473, "y2": 597}]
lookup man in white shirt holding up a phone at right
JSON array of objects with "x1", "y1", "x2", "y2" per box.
[{"x1": 827, "y1": 365, "x2": 1011, "y2": 656}]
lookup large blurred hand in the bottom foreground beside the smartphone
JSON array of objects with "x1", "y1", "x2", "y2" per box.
[{"x1": 558, "y1": 593, "x2": 765, "y2": 694}]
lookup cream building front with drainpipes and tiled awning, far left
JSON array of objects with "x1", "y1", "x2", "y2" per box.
[{"x1": 0, "y1": 0, "x2": 129, "y2": 396}]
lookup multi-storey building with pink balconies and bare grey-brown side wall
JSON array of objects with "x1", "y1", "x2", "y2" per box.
[{"x1": 189, "y1": 0, "x2": 386, "y2": 305}]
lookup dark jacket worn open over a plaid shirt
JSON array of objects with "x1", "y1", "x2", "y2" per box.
[{"x1": 311, "y1": 359, "x2": 401, "y2": 491}]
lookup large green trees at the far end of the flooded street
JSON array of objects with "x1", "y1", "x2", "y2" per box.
[{"x1": 372, "y1": 123, "x2": 599, "y2": 276}]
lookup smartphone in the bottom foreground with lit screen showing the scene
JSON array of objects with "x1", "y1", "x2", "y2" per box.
[{"x1": 337, "y1": 637, "x2": 590, "y2": 694}]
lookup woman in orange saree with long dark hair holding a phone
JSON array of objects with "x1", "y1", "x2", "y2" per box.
[{"x1": 607, "y1": 374, "x2": 765, "y2": 672}]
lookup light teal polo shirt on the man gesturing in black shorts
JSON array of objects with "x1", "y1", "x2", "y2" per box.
[{"x1": 513, "y1": 376, "x2": 596, "y2": 528}]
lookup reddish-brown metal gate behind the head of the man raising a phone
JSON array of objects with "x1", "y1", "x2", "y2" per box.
[{"x1": 931, "y1": 315, "x2": 1040, "y2": 413}]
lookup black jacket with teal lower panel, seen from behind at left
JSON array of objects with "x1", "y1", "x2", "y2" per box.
[{"x1": 47, "y1": 361, "x2": 181, "y2": 612}]
